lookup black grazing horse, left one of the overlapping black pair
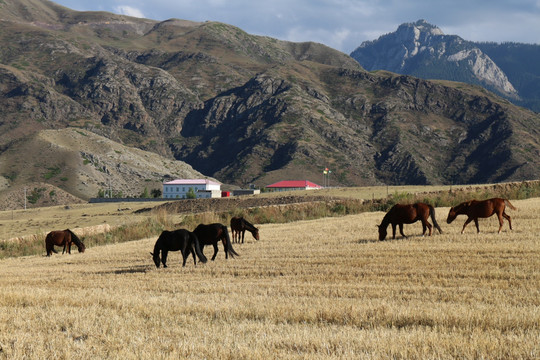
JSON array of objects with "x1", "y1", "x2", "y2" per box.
[{"x1": 150, "y1": 229, "x2": 208, "y2": 268}]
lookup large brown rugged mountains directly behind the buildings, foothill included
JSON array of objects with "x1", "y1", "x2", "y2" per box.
[{"x1": 0, "y1": 0, "x2": 540, "y2": 205}]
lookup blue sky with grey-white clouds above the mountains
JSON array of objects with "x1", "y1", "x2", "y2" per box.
[{"x1": 54, "y1": 0, "x2": 540, "y2": 54}]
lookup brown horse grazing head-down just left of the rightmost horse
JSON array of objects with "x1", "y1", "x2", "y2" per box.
[{"x1": 378, "y1": 203, "x2": 442, "y2": 240}]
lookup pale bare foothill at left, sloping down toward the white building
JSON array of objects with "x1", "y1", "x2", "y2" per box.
[{"x1": 0, "y1": 128, "x2": 212, "y2": 205}]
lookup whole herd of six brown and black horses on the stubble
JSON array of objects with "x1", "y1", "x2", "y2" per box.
[{"x1": 45, "y1": 198, "x2": 517, "y2": 268}]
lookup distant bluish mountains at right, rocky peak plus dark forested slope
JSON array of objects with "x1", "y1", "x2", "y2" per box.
[{"x1": 351, "y1": 20, "x2": 540, "y2": 112}]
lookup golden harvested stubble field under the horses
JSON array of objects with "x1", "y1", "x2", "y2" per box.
[{"x1": 0, "y1": 199, "x2": 540, "y2": 359}]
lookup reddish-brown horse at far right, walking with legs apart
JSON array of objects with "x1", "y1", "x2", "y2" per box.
[{"x1": 446, "y1": 198, "x2": 517, "y2": 234}]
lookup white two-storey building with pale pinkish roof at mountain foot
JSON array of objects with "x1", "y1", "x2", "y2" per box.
[{"x1": 163, "y1": 179, "x2": 221, "y2": 199}]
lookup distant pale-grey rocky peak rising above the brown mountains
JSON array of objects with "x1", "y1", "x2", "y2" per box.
[{"x1": 351, "y1": 20, "x2": 519, "y2": 99}]
